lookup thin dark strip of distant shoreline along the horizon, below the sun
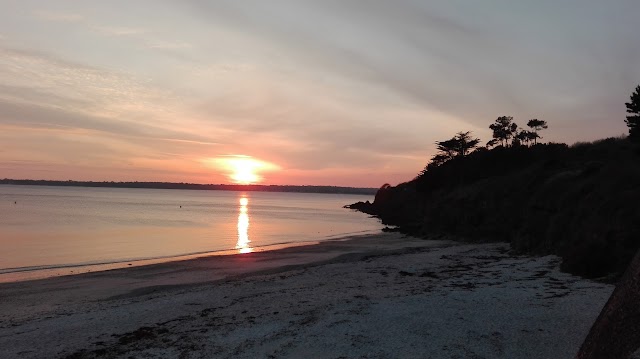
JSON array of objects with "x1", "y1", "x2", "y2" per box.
[{"x1": 0, "y1": 178, "x2": 377, "y2": 195}]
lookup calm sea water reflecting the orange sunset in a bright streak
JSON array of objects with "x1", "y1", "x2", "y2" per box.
[{"x1": 0, "y1": 185, "x2": 382, "y2": 281}]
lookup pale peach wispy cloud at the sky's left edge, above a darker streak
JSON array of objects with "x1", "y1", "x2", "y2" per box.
[{"x1": 0, "y1": 48, "x2": 222, "y2": 148}]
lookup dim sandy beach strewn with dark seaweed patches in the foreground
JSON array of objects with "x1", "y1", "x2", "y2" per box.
[{"x1": 0, "y1": 233, "x2": 613, "y2": 358}]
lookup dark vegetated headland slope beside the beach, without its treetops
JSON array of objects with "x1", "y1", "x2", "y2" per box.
[{"x1": 349, "y1": 138, "x2": 640, "y2": 280}]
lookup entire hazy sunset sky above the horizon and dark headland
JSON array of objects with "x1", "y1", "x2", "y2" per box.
[{"x1": 0, "y1": 0, "x2": 640, "y2": 187}]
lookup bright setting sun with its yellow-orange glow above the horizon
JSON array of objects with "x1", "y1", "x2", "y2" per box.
[{"x1": 203, "y1": 155, "x2": 280, "y2": 184}]
